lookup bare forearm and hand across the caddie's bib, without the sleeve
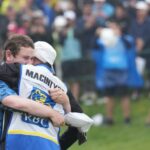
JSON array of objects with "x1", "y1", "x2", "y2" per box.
[{"x1": 2, "y1": 95, "x2": 64, "y2": 126}]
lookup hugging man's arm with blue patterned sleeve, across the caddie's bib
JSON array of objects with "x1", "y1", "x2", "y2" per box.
[{"x1": 0, "y1": 81, "x2": 64, "y2": 126}]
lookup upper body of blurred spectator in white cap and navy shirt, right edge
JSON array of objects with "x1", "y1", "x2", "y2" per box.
[{"x1": 129, "y1": 1, "x2": 150, "y2": 53}]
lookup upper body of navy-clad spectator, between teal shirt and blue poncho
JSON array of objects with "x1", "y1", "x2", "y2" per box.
[{"x1": 76, "y1": 3, "x2": 97, "y2": 58}]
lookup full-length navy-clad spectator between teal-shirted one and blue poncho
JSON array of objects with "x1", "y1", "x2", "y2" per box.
[{"x1": 76, "y1": 2, "x2": 98, "y2": 105}]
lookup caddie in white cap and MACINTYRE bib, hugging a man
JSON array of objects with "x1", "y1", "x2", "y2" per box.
[{"x1": 0, "y1": 41, "x2": 67, "y2": 150}]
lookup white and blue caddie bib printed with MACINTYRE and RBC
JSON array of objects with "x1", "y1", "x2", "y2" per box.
[{"x1": 1, "y1": 65, "x2": 67, "y2": 150}]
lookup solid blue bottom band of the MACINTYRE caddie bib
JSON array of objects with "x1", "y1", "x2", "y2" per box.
[{"x1": 6, "y1": 134, "x2": 60, "y2": 150}]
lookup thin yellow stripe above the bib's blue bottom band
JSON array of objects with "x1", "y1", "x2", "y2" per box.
[{"x1": 8, "y1": 130, "x2": 58, "y2": 144}]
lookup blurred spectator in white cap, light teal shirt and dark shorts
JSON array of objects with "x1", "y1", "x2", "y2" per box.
[{"x1": 61, "y1": 10, "x2": 81, "y2": 100}]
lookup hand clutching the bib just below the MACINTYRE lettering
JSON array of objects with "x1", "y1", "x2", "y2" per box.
[{"x1": 48, "y1": 88, "x2": 71, "y2": 112}]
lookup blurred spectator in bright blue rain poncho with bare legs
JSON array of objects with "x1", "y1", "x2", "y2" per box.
[{"x1": 94, "y1": 20, "x2": 143, "y2": 125}]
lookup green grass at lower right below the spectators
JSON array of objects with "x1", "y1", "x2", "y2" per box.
[{"x1": 69, "y1": 98, "x2": 150, "y2": 150}]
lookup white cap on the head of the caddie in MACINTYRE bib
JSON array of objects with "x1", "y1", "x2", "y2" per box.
[{"x1": 34, "y1": 41, "x2": 56, "y2": 65}]
